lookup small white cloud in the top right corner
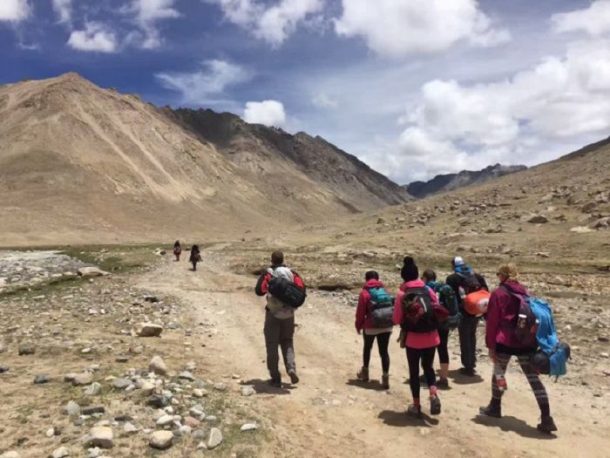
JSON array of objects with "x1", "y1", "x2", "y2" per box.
[{"x1": 551, "y1": 0, "x2": 610, "y2": 36}]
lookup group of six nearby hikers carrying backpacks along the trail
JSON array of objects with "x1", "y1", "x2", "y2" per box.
[{"x1": 255, "y1": 251, "x2": 569, "y2": 433}]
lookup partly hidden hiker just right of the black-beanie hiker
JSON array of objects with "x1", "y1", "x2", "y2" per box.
[{"x1": 422, "y1": 269, "x2": 462, "y2": 388}]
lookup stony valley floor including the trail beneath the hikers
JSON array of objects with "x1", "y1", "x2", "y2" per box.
[{"x1": 0, "y1": 247, "x2": 610, "y2": 457}]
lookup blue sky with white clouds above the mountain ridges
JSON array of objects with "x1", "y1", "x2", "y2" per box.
[{"x1": 0, "y1": 0, "x2": 610, "y2": 183}]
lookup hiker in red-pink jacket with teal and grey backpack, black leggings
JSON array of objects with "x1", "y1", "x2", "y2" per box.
[{"x1": 356, "y1": 270, "x2": 394, "y2": 390}]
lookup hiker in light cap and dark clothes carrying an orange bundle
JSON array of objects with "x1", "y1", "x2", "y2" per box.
[{"x1": 445, "y1": 256, "x2": 489, "y2": 376}]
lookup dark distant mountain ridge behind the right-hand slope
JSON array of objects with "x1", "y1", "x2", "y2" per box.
[{"x1": 404, "y1": 164, "x2": 527, "y2": 198}]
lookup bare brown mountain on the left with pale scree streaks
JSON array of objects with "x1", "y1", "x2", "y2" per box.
[{"x1": 0, "y1": 73, "x2": 407, "y2": 245}]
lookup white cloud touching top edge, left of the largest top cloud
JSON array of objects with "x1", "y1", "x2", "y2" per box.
[{"x1": 204, "y1": 0, "x2": 324, "y2": 46}]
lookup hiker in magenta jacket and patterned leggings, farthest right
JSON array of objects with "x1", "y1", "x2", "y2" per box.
[{"x1": 480, "y1": 264, "x2": 557, "y2": 433}]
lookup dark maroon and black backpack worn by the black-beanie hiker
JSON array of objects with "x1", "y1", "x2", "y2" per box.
[{"x1": 402, "y1": 287, "x2": 449, "y2": 332}]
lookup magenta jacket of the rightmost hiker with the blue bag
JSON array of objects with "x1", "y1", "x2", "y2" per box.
[{"x1": 485, "y1": 280, "x2": 528, "y2": 350}]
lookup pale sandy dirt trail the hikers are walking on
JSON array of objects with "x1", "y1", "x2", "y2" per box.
[{"x1": 139, "y1": 251, "x2": 609, "y2": 457}]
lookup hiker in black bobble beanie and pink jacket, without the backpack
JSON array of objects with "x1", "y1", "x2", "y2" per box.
[{"x1": 394, "y1": 256, "x2": 441, "y2": 417}]
